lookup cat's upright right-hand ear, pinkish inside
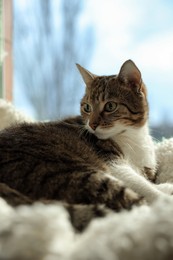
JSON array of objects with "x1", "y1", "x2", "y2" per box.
[{"x1": 118, "y1": 60, "x2": 142, "y2": 92}]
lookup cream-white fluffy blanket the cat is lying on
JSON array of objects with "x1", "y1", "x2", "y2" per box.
[{"x1": 0, "y1": 100, "x2": 173, "y2": 260}]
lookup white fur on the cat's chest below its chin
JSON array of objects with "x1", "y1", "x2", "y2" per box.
[{"x1": 114, "y1": 124, "x2": 156, "y2": 174}]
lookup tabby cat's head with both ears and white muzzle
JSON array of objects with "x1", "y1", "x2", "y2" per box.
[{"x1": 77, "y1": 60, "x2": 148, "y2": 139}]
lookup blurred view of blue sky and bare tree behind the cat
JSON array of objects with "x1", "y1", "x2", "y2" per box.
[{"x1": 5, "y1": 0, "x2": 173, "y2": 139}]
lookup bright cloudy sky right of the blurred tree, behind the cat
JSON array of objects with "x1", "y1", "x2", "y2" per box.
[{"x1": 15, "y1": 0, "x2": 173, "y2": 124}]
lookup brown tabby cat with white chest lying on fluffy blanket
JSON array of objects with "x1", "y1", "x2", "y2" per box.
[{"x1": 0, "y1": 60, "x2": 172, "y2": 215}]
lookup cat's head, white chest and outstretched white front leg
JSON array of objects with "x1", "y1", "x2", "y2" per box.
[{"x1": 77, "y1": 60, "x2": 173, "y2": 202}]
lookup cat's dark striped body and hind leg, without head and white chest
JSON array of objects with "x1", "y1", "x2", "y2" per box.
[{"x1": 0, "y1": 117, "x2": 137, "y2": 210}]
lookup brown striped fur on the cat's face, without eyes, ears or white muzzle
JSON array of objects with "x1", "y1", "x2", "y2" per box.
[{"x1": 81, "y1": 76, "x2": 148, "y2": 128}]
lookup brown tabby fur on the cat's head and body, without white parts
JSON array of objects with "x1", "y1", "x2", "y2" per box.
[{"x1": 0, "y1": 60, "x2": 148, "y2": 229}]
